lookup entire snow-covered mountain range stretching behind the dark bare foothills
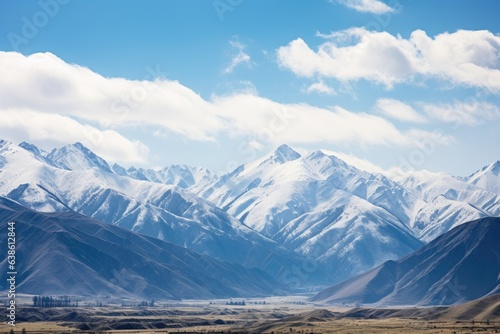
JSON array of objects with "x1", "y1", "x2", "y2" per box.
[{"x1": 0, "y1": 140, "x2": 500, "y2": 287}]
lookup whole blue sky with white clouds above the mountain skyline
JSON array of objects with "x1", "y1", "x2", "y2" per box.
[{"x1": 0, "y1": 0, "x2": 500, "y2": 175}]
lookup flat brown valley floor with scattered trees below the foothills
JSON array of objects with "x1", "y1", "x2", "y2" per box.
[{"x1": 0, "y1": 301, "x2": 500, "y2": 334}]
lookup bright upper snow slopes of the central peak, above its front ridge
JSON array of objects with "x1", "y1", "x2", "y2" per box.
[{"x1": 197, "y1": 145, "x2": 415, "y2": 237}]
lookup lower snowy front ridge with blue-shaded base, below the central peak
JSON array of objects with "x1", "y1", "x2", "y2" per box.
[{"x1": 274, "y1": 190, "x2": 422, "y2": 283}]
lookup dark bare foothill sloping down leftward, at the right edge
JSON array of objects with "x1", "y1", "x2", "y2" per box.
[{"x1": 312, "y1": 217, "x2": 500, "y2": 305}]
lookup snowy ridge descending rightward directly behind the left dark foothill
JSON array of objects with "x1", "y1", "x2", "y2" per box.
[{"x1": 0, "y1": 142, "x2": 312, "y2": 284}]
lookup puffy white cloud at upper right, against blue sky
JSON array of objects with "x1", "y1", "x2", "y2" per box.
[{"x1": 277, "y1": 28, "x2": 500, "y2": 94}]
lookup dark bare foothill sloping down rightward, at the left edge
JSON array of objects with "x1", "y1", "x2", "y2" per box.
[{"x1": 0, "y1": 197, "x2": 285, "y2": 299}]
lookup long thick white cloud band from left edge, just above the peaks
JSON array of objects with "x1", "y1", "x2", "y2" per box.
[{"x1": 0, "y1": 52, "x2": 456, "y2": 163}]
